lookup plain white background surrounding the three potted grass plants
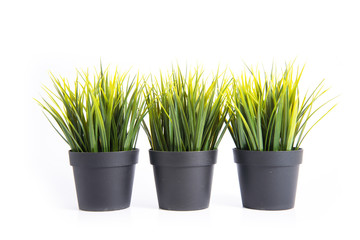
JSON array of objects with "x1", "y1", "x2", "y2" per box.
[{"x1": 0, "y1": 0, "x2": 360, "y2": 239}]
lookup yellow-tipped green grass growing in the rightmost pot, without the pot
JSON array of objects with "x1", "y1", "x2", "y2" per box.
[{"x1": 227, "y1": 63, "x2": 335, "y2": 151}]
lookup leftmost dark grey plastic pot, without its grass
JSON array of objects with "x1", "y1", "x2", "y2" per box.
[{"x1": 69, "y1": 149, "x2": 139, "y2": 211}]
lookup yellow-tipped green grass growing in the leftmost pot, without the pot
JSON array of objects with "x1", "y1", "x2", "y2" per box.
[{"x1": 38, "y1": 67, "x2": 147, "y2": 152}]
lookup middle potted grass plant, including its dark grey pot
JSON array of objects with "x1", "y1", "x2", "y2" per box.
[{"x1": 143, "y1": 67, "x2": 227, "y2": 211}]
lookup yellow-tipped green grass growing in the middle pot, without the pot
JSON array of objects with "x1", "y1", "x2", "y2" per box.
[{"x1": 143, "y1": 67, "x2": 228, "y2": 151}]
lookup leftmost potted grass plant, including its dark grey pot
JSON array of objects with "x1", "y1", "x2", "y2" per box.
[{"x1": 38, "y1": 67, "x2": 147, "y2": 211}]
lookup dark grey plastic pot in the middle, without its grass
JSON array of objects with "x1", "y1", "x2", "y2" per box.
[{"x1": 149, "y1": 150, "x2": 217, "y2": 211}]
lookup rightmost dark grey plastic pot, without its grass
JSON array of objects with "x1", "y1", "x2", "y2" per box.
[{"x1": 233, "y1": 149, "x2": 303, "y2": 210}]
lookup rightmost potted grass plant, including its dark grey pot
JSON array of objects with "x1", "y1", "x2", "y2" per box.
[{"x1": 227, "y1": 63, "x2": 335, "y2": 210}]
